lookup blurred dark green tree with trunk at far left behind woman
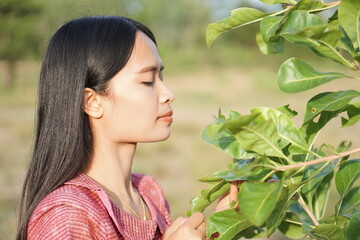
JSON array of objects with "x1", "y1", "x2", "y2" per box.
[{"x1": 0, "y1": 0, "x2": 42, "y2": 87}]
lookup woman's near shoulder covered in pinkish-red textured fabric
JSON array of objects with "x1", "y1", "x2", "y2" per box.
[{"x1": 28, "y1": 185, "x2": 107, "y2": 239}]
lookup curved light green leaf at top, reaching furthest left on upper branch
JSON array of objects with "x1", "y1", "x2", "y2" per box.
[{"x1": 206, "y1": 8, "x2": 272, "y2": 47}]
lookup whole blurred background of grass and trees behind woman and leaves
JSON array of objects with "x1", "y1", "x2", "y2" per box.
[{"x1": 0, "y1": 0, "x2": 360, "y2": 240}]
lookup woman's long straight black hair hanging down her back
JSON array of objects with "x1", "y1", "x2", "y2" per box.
[{"x1": 16, "y1": 16, "x2": 156, "y2": 240}]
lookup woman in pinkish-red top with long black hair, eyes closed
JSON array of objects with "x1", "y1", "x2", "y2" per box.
[{"x1": 17, "y1": 17, "x2": 205, "y2": 240}]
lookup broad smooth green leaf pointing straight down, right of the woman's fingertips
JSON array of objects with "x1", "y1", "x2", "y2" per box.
[{"x1": 239, "y1": 181, "x2": 282, "y2": 226}]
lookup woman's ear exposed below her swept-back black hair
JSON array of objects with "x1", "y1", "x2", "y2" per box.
[{"x1": 84, "y1": 88, "x2": 104, "y2": 119}]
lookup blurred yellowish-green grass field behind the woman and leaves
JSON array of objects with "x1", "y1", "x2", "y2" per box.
[{"x1": 0, "y1": 47, "x2": 360, "y2": 240}]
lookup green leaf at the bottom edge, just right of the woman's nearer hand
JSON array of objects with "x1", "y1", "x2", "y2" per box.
[{"x1": 206, "y1": 209, "x2": 252, "y2": 240}]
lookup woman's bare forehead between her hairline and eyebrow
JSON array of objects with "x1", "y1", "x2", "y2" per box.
[{"x1": 125, "y1": 31, "x2": 162, "y2": 71}]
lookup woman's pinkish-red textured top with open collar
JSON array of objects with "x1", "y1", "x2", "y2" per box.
[{"x1": 28, "y1": 173, "x2": 171, "y2": 240}]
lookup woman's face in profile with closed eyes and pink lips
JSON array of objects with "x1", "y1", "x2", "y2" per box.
[{"x1": 102, "y1": 31, "x2": 174, "y2": 142}]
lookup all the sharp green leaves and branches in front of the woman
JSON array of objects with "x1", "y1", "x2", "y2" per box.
[{"x1": 189, "y1": 0, "x2": 360, "y2": 240}]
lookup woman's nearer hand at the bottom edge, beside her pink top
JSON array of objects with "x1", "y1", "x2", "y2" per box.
[{"x1": 163, "y1": 213, "x2": 206, "y2": 240}]
